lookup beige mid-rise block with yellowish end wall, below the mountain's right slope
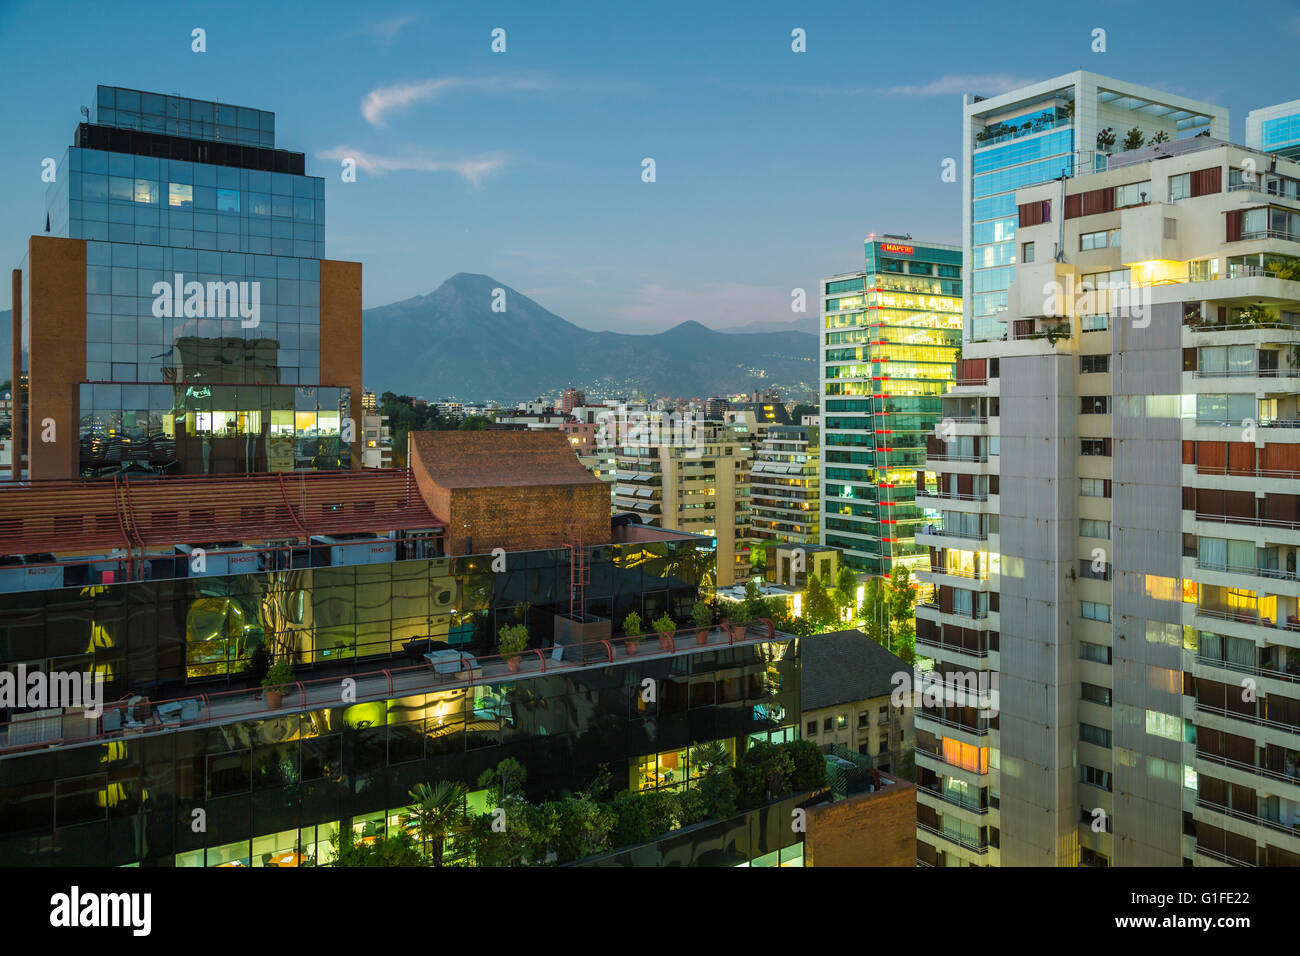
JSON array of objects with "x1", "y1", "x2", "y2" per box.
[{"x1": 614, "y1": 416, "x2": 754, "y2": 588}]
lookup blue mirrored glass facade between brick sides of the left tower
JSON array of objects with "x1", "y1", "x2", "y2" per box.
[{"x1": 47, "y1": 86, "x2": 350, "y2": 477}]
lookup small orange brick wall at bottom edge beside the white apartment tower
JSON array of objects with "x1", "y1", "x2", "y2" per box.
[{"x1": 803, "y1": 780, "x2": 917, "y2": 866}]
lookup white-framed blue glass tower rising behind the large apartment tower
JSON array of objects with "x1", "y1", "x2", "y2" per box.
[{"x1": 962, "y1": 70, "x2": 1227, "y2": 342}]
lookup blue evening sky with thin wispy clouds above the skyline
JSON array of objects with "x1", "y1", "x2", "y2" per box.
[{"x1": 0, "y1": 0, "x2": 1300, "y2": 332}]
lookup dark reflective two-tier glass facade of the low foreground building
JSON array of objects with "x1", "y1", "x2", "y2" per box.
[{"x1": 0, "y1": 538, "x2": 801, "y2": 866}]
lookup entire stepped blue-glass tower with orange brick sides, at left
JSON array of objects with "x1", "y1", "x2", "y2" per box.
[{"x1": 12, "y1": 86, "x2": 361, "y2": 479}]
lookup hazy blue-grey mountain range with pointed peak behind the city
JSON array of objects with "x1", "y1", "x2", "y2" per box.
[{"x1": 361, "y1": 272, "x2": 818, "y2": 402}]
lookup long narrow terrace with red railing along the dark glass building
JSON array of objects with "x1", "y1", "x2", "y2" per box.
[{"x1": 0, "y1": 618, "x2": 777, "y2": 753}]
